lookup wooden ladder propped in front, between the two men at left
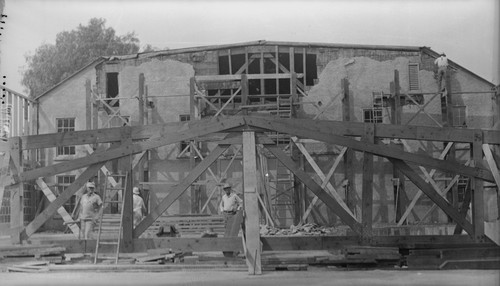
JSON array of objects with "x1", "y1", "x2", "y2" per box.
[{"x1": 94, "y1": 173, "x2": 128, "y2": 264}]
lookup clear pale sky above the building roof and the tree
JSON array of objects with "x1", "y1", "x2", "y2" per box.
[{"x1": 0, "y1": 0, "x2": 500, "y2": 94}]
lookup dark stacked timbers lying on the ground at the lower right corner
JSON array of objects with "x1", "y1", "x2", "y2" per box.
[{"x1": 406, "y1": 247, "x2": 500, "y2": 269}]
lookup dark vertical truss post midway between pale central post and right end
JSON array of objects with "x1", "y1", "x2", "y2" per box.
[{"x1": 361, "y1": 124, "x2": 375, "y2": 241}]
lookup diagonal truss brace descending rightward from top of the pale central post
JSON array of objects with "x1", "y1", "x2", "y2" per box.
[{"x1": 259, "y1": 138, "x2": 361, "y2": 234}]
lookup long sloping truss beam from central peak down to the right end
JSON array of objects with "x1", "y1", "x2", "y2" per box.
[{"x1": 245, "y1": 118, "x2": 493, "y2": 182}]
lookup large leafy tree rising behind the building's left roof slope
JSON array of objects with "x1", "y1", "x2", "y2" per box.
[{"x1": 21, "y1": 18, "x2": 140, "y2": 97}]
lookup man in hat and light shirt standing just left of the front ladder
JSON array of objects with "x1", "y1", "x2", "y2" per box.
[{"x1": 79, "y1": 182, "x2": 102, "y2": 239}]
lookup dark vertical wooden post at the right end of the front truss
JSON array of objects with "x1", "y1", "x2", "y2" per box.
[{"x1": 471, "y1": 131, "x2": 484, "y2": 241}]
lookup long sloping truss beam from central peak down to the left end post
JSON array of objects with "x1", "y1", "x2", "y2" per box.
[{"x1": 19, "y1": 118, "x2": 244, "y2": 181}]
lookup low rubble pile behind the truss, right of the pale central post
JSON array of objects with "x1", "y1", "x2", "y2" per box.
[{"x1": 260, "y1": 223, "x2": 347, "y2": 236}]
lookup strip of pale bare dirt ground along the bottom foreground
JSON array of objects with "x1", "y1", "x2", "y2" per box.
[{"x1": 0, "y1": 269, "x2": 500, "y2": 286}]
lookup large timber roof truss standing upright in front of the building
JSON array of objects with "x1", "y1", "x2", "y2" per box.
[{"x1": 0, "y1": 112, "x2": 500, "y2": 273}]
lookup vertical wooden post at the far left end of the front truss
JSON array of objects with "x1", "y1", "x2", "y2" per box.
[{"x1": 9, "y1": 137, "x2": 24, "y2": 244}]
